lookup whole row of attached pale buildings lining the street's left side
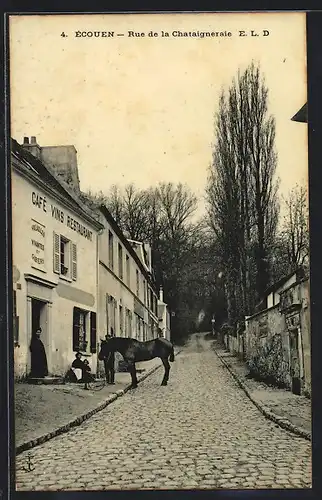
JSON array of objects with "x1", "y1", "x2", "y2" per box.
[{"x1": 11, "y1": 137, "x2": 170, "y2": 377}]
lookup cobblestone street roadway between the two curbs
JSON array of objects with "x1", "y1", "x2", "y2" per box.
[{"x1": 16, "y1": 336, "x2": 311, "y2": 490}]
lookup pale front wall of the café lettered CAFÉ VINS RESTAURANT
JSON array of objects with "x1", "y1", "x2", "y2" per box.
[{"x1": 12, "y1": 168, "x2": 97, "y2": 377}]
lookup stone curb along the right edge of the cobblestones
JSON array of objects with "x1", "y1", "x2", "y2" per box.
[{"x1": 213, "y1": 347, "x2": 311, "y2": 441}]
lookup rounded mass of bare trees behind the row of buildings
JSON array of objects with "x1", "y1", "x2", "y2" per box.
[{"x1": 84, "y1": 183, "x2": 218, "y2": 339}]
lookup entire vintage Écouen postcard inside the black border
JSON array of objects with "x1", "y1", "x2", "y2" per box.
[{"x1": 8, "y1": 12, "x2": 311, "y2": 491}]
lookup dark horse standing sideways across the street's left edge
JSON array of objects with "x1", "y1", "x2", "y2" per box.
[{"x1": 98, "y1": 337, "x2": 174, "y2": 389}]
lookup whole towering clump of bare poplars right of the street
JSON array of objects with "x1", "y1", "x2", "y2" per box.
[{"x1": 206, "y1": 63, "x2": 278, "y2": 326}]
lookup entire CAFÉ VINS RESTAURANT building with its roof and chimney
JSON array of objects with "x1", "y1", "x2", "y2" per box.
[{"x1": 11, "y1": 138, "x2": 102, "y2": 378}]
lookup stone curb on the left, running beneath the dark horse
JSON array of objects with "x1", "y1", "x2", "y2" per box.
[{"x1": 16, "y1": 349, "x2": 183, "y2": 456}]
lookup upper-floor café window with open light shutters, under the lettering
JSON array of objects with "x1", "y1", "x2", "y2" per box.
[{"x1": 54, "y1": 233, "x2": 77, "y2": 281}]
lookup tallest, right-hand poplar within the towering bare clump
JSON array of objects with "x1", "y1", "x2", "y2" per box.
[{"x1": 241, "y1": 63, "x2": 279, "y2": 298}]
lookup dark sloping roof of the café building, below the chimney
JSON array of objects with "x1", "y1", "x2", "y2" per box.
[{"x1": 11, "y1": 139, "x2": 103, "y2": 229}]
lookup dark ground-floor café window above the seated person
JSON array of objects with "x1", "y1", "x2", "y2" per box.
[{"x1": 73, "y1": 307, "x2": 97, "y2": 353}]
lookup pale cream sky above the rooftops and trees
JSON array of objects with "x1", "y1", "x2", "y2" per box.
[{"x1": 9, "y1": 12, "x2": 308, "y2": 214}]
